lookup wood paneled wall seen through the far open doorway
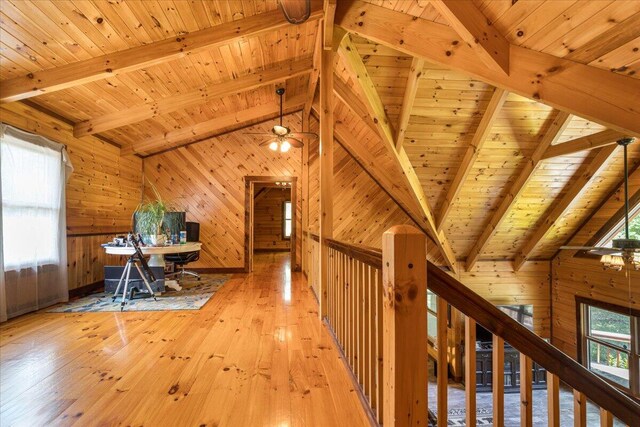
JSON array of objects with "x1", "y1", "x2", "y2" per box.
[{"x1": 253, "y1": 187, "x2": 291, "y2": 250}]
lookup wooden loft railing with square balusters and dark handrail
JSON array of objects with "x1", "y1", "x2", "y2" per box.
[{"x1": 303, "y1": 231, "x2": 640, "y2": 426}]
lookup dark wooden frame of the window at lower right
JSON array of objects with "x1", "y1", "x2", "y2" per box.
[{"x1": 575, "y1": 296, "x2": 640, "y2": 399}]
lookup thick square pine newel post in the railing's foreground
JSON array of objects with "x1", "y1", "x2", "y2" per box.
[{"x1": 382, "y1": 225, "x2": 428, "y2": 427}]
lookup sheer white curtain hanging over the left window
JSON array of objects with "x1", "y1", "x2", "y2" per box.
[{"x1": 0, "y1": 124, "x2": 73, "y2": 321}]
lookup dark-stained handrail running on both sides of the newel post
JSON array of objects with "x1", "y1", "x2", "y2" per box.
[{"x1": 308, "y1": 233, "x2": 640, "y2": 426}]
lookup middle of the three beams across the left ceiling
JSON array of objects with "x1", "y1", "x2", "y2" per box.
[{"x1": 73, "y1": 58, "x2": 313, "y2": 138}]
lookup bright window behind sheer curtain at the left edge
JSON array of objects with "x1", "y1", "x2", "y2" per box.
[{"x1": 0, "y1": 134, "x2": 64, "y2": 271}]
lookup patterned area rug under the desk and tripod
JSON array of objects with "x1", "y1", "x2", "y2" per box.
[{"x1": 47, "y1": 274, "x2": 230, "y2": 313}]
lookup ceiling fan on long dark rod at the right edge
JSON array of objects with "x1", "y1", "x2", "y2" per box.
[{"x1": 560, "y1": 138, "x2": 640, "y2": 270}]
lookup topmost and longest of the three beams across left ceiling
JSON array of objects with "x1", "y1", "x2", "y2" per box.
[{"x1": 0, "y1": 9, "x2": 322, "y2": 103}]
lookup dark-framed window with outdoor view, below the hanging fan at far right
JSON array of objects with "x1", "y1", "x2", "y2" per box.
[{"x1": 577, "y1": 297, "x2": 640, "y2": 396}]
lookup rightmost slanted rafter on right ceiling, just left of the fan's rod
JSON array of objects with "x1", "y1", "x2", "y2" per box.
[{"x1": 513, "y1": 145, "x2": 618, "y2": 271}]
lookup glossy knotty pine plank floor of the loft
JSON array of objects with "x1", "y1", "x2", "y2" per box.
[{"x1": 0, "y1": 253, "x2": 369, "y2": 426}]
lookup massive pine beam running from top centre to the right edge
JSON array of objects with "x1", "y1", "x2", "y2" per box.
[{"x1": 336, "y1": 0, "x2": 640, "y2": 136}]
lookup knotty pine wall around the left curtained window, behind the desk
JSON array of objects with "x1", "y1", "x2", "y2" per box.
[{"x1": 0, "y1": 103, "x2": 142, "y2": 290}]
